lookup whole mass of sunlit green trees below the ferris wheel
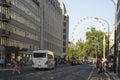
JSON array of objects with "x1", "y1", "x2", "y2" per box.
[{"x1": 67, "y1": 27, "x2": 108, "y2": 59}]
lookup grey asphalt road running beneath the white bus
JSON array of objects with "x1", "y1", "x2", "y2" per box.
[{"x1": 0, "y1": 64, "x2": 111, "y2": 80}]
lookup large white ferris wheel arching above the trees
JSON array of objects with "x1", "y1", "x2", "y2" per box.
[{"x1": 71, "y1": 17, "x2": 109, "y2": 43}]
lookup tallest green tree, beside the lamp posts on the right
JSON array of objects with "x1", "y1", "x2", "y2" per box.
[{"x1": 86, "y1": 27, "x2": 108, "y2": 57}]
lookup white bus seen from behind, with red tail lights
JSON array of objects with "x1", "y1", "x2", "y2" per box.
[{"x1": 32, "y1": 50, "x2": 55, "y2": 69}]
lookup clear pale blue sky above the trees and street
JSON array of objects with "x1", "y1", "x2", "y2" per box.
[{"x1": 62, "y1": 0, "x2": 116, "y2": 41}]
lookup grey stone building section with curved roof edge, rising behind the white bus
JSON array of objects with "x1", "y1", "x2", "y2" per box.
[{"x1": 42, "y1": 0, "x2": 69, "y2": 57}]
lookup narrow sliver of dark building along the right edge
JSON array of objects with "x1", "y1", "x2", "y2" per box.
[{"x1": 114, "y1": 0, "x2": 120, "y2": 77}]
